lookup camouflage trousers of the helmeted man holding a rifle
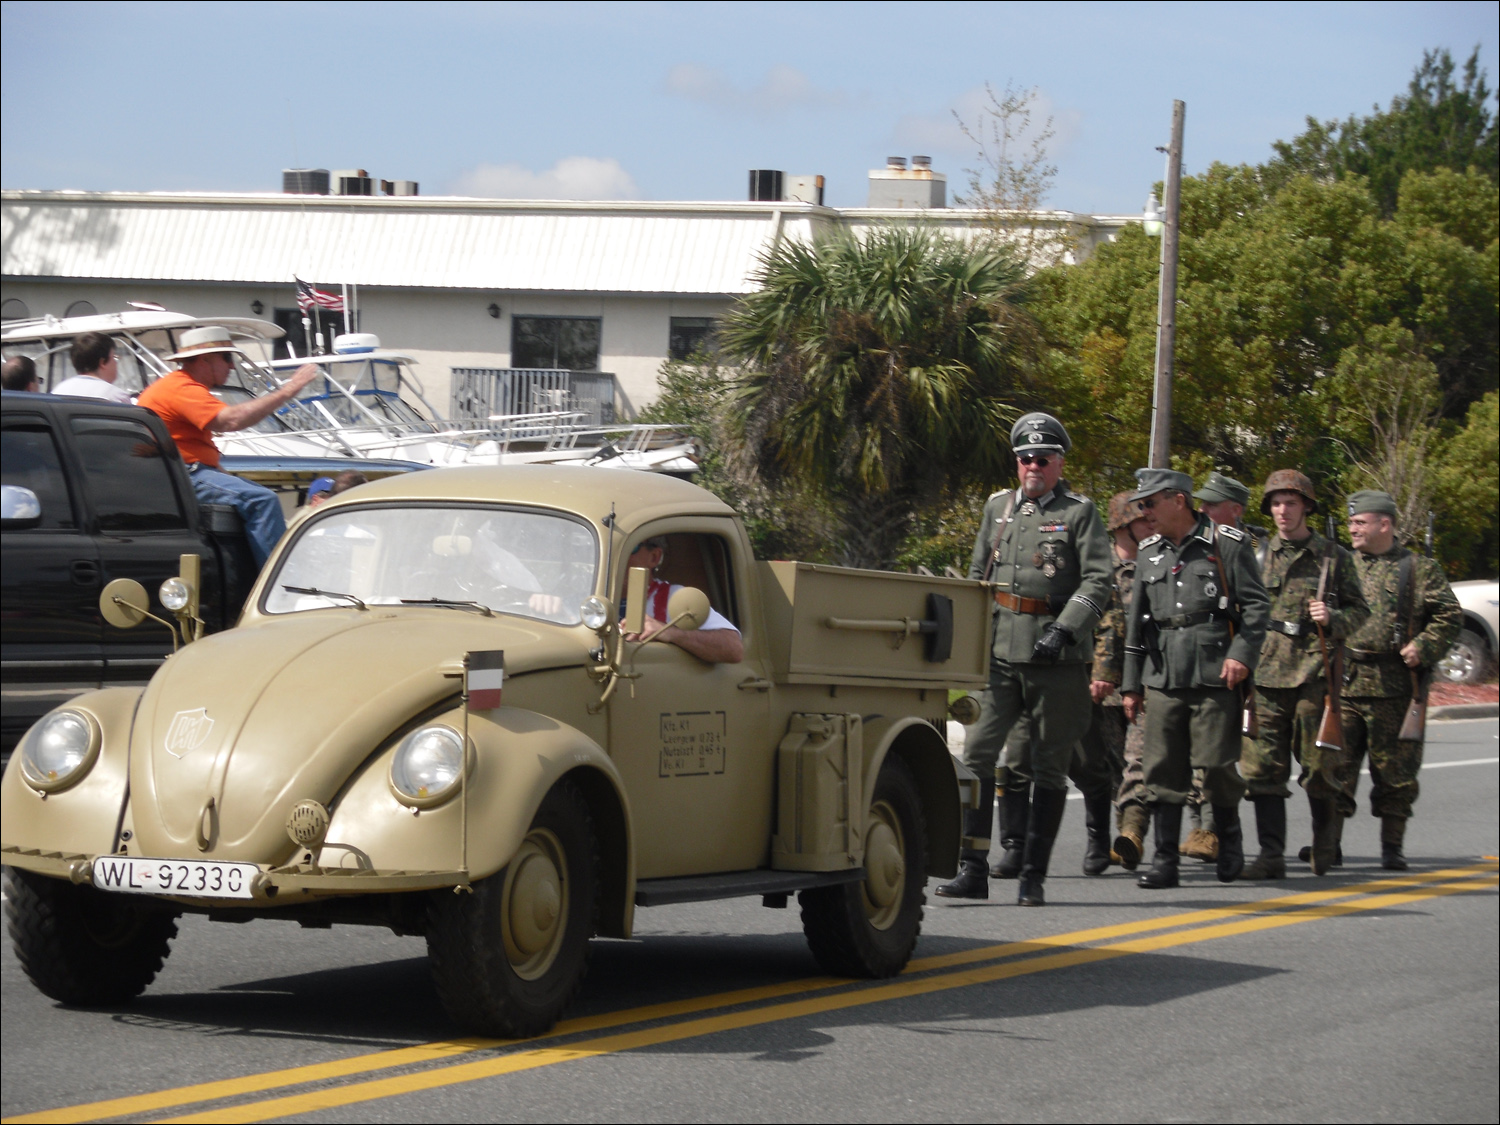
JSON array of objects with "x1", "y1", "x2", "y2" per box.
[{"x1": 1239, "y1": 680, "x2": 1344, "y2": 812}]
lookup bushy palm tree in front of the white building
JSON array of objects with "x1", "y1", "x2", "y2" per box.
[{"x1": 719, "y1": 227, "x2": 1034, "y2": 569}]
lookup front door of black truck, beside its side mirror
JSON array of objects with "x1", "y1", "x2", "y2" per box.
[{"x1": 0, "y1": 411, "x2": 104, "y2": 737}]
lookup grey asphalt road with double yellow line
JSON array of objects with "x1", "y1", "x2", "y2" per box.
[{"x1": 0, "y1": 720, "x2": 1500, "y2": 1122}]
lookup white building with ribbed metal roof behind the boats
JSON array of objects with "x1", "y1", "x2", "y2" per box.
[{"x1": 0, "y1": 191, "x2": 1137, "y2": 419}]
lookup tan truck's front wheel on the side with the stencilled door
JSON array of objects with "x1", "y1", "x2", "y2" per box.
[{"x1": 428, "y1": 782, "x2": 599, "y2": 1038}]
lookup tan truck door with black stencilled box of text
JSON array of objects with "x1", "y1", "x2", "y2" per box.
[{"x1": 609, "y1": 521, "x2": 776, "y2": 879}]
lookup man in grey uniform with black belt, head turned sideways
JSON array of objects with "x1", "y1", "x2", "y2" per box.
[{"x1": 1121, "y1": 468, "x2": 1269, "y2": 890}]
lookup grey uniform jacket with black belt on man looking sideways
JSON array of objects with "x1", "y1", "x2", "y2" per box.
[{"x1": 1121, "y1": 515, "x2": 1266, "y2": 693}]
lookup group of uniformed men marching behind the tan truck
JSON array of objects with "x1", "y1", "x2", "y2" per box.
[{"x1": 938, "y1": 413, "x2": 1461, "y2": 906}]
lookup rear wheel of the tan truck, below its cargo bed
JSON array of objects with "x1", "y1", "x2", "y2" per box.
[{"x1": 798, "y1": 755, "x2": 927, "y2": 977}]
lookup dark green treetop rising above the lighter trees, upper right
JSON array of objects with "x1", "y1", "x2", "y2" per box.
[{"x1": 1268, "y1": 47, "x2": 1500, "y2": 216}]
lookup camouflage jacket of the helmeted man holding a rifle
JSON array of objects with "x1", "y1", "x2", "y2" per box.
[{"x1": 1256, "y1": 531, "x2": 1370, "y2": 687}]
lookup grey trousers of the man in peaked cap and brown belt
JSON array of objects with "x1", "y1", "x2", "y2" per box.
[{"x1": 963, "y1": 662, "x2": 1091, "y2": 789}]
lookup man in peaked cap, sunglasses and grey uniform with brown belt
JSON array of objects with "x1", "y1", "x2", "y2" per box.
[{"x1": 938, "y1": 413, "x2": 1113, "y2": 906}]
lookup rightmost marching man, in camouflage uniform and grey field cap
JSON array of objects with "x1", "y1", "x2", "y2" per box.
[{"x1": 1341, "y1": 491, "x2": 1464, "y2": 872}]
